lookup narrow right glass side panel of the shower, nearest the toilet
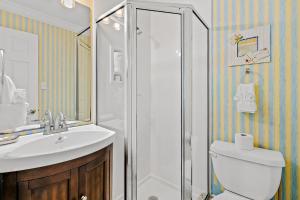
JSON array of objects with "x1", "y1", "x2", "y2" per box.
[{"x1": 191, "y1": 14, "x2": 209, "y2": 200}]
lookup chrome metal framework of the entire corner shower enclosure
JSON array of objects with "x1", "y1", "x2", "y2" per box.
[{"x1": 96, "y1": 0, "x2": 210, "y2": 200}]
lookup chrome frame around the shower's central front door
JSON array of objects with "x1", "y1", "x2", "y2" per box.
[{"x1": 125, "y1": 1, "x2": 192, "y2": 200}]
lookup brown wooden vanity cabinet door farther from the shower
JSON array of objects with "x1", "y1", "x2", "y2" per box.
[{"x1": 18, "y1": 171, "x2": 78, "y2": 200}]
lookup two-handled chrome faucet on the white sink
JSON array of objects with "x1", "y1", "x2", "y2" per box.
[{"x1": 41, "y1": 111, "x2": 68, "y2": 135}]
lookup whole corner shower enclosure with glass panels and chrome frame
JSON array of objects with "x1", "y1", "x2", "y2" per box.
[{"x1": 96, "y1": 1, "x2": 209, "y2": 200}]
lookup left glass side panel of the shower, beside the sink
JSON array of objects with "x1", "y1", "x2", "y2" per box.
[{"x1": 97, "y1": 8, "x2": 126, "y2": 200}]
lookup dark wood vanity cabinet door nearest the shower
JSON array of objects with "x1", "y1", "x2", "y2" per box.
[{"x1": 78, "y1": 152, "x2": 111, "y2": 200}]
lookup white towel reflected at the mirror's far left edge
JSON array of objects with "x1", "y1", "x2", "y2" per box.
[{"x1": 0, "y1": 75, "x2": 16, "y2": 104}]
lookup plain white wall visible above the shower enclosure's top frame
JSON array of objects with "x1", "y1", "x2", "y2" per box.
[{"x1": 94, "y1": 0, "x2": 212, "y2": 26}]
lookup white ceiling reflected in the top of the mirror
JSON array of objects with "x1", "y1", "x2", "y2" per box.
[{"x1": 0, "y1": 0, "x2": 90, "y2": 32}]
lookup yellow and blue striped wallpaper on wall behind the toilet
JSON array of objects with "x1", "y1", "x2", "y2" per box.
[{"x1": 211, "y1": 0, "x2": 300, "y2": 200}]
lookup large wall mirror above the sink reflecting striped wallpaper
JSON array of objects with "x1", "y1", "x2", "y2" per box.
[{"x1": 0, "y1": 0, "x2": 92, "y2": 132}]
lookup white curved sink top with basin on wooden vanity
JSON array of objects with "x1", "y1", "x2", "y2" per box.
[{"x1": 0, "y1": 125, "x2": 115, "y2": 173}]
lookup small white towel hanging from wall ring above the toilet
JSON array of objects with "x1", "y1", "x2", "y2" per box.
[{"x1": 234, "y1": 83, "x2": 257, "y2": 113}]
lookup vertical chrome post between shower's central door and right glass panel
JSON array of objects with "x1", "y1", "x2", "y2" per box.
[{"x1": 181, "y1": 8, "x2": 193, "y2": 200}]
